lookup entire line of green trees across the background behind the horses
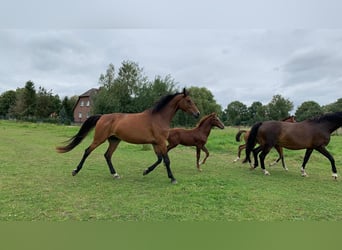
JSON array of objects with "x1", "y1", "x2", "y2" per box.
[{"x1": 0, "y1": 61, "x2": 342, "y2": 127}]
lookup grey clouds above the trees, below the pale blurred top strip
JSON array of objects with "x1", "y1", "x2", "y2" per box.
[{"x1": 0, "y1": 29, "x2": 342, "y2": 108}]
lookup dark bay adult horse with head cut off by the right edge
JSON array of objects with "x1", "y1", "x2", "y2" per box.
[{"x1": 245, "y1": 112, "x2": 342, "y2": 179}]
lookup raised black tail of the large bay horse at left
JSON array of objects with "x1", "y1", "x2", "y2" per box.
[{"x1": 56, "y1": 115, "x2": 101, "y2": 153}]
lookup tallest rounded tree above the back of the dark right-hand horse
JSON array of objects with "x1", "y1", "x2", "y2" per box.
[{"x1": 266, "y1": 95, "x2": 293, "y2": 120}]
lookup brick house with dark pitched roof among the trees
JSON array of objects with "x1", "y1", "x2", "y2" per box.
[{"x1": 73, "y1": 88, "x2": 99, "y2": 123}]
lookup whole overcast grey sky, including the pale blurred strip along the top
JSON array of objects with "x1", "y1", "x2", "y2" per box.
[{"x1": 0, "y1": 0, "x2": 342, "y2": 108}]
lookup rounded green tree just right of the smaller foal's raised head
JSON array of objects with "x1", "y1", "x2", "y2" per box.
[{"x1": 224, "y1": 101, "x2": 248, "y2": 125}]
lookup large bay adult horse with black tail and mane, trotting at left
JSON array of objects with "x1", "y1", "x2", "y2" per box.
[{"x1": 56, "y1": 88, "x2": 200, "y2": 183}]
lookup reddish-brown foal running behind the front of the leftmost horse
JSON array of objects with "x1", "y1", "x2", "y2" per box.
[{"x1": 167, "y1": 113, "x2": 224, "y2": 171}]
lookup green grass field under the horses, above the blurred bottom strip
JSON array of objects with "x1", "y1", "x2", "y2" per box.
[{"x1": 0, "y1": 121, "x2": 342, "y2": 222}]
